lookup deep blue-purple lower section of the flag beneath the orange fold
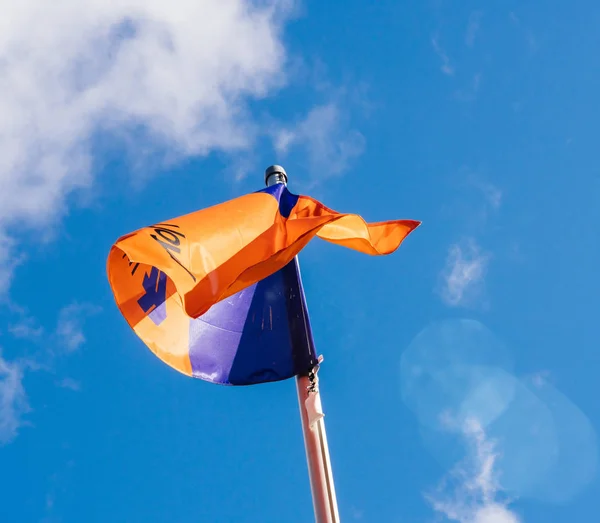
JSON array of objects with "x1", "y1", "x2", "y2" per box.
[{"x1": 189, "y1": 259, "x2": 317, "y2": 385}]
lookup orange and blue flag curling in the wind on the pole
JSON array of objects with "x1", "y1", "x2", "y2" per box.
[{"x1": 107, "y1": 184, "x2": 419, "y2": 385}]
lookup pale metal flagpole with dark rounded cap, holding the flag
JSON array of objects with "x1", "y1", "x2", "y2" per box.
[{"x1": 265, "y1": 165, "x2": 340, "y2": 523}]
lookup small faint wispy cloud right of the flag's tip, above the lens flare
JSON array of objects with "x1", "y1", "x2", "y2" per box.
[{"x1": 440, "y1": 239, "x2": 490, "y2": 307}]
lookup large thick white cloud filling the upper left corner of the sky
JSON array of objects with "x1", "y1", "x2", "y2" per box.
[{"x1": 0, "y1": 0, "x2": 293, "y2": 289}]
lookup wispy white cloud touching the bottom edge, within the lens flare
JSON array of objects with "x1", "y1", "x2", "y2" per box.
[{"x1": 425, "y1": 418, "x2": 522, "y2": 523}]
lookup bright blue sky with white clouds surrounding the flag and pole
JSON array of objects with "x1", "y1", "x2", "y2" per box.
[{"x1": 0, "y1": 0, "x2": 600, "y2": 523}]
